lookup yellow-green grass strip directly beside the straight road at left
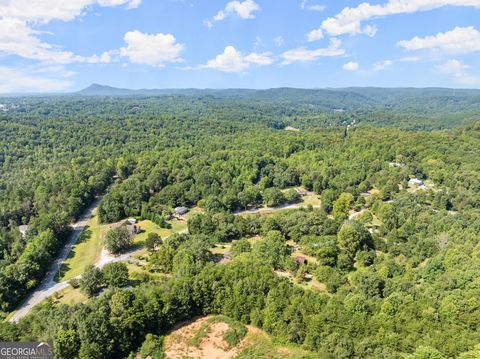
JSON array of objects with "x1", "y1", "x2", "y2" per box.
[{"x1": 56, "y1": 209, "x2": 108, "y2": 282}]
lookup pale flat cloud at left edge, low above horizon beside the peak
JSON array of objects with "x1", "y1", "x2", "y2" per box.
[{"x1": 0, "y1": 66, "x2": 72, "y2": 93}]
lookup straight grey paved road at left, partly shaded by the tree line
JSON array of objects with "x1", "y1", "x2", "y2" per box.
[{"x1": 10, "y1": 198, "x2": 100, "y2": 322}]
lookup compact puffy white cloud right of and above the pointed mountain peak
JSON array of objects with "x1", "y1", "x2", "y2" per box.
[{"x1": 120, "y1": 30, "x2": 185, "y2": 67}]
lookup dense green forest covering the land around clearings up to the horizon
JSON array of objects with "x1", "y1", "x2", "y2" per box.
[{"x1": 0, "y1": 89, "x2": 480, "y2": 359}]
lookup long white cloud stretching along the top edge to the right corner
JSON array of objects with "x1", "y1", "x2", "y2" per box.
[{"x1": 322, "y1": 0, "x2": 480, "y2": 36}]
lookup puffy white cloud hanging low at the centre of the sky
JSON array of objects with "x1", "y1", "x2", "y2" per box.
[{"x1": 200, "y1": 46, "x2": 273, "y2": 72}]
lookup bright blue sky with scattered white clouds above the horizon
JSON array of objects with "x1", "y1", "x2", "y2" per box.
[{"x1": 0, "y1": 0, "x2": 480, "y2": 93}]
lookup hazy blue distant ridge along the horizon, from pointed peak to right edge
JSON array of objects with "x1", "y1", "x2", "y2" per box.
[{"x1": 74, "y1": 84, "x2": 480, "y2": 111}]
